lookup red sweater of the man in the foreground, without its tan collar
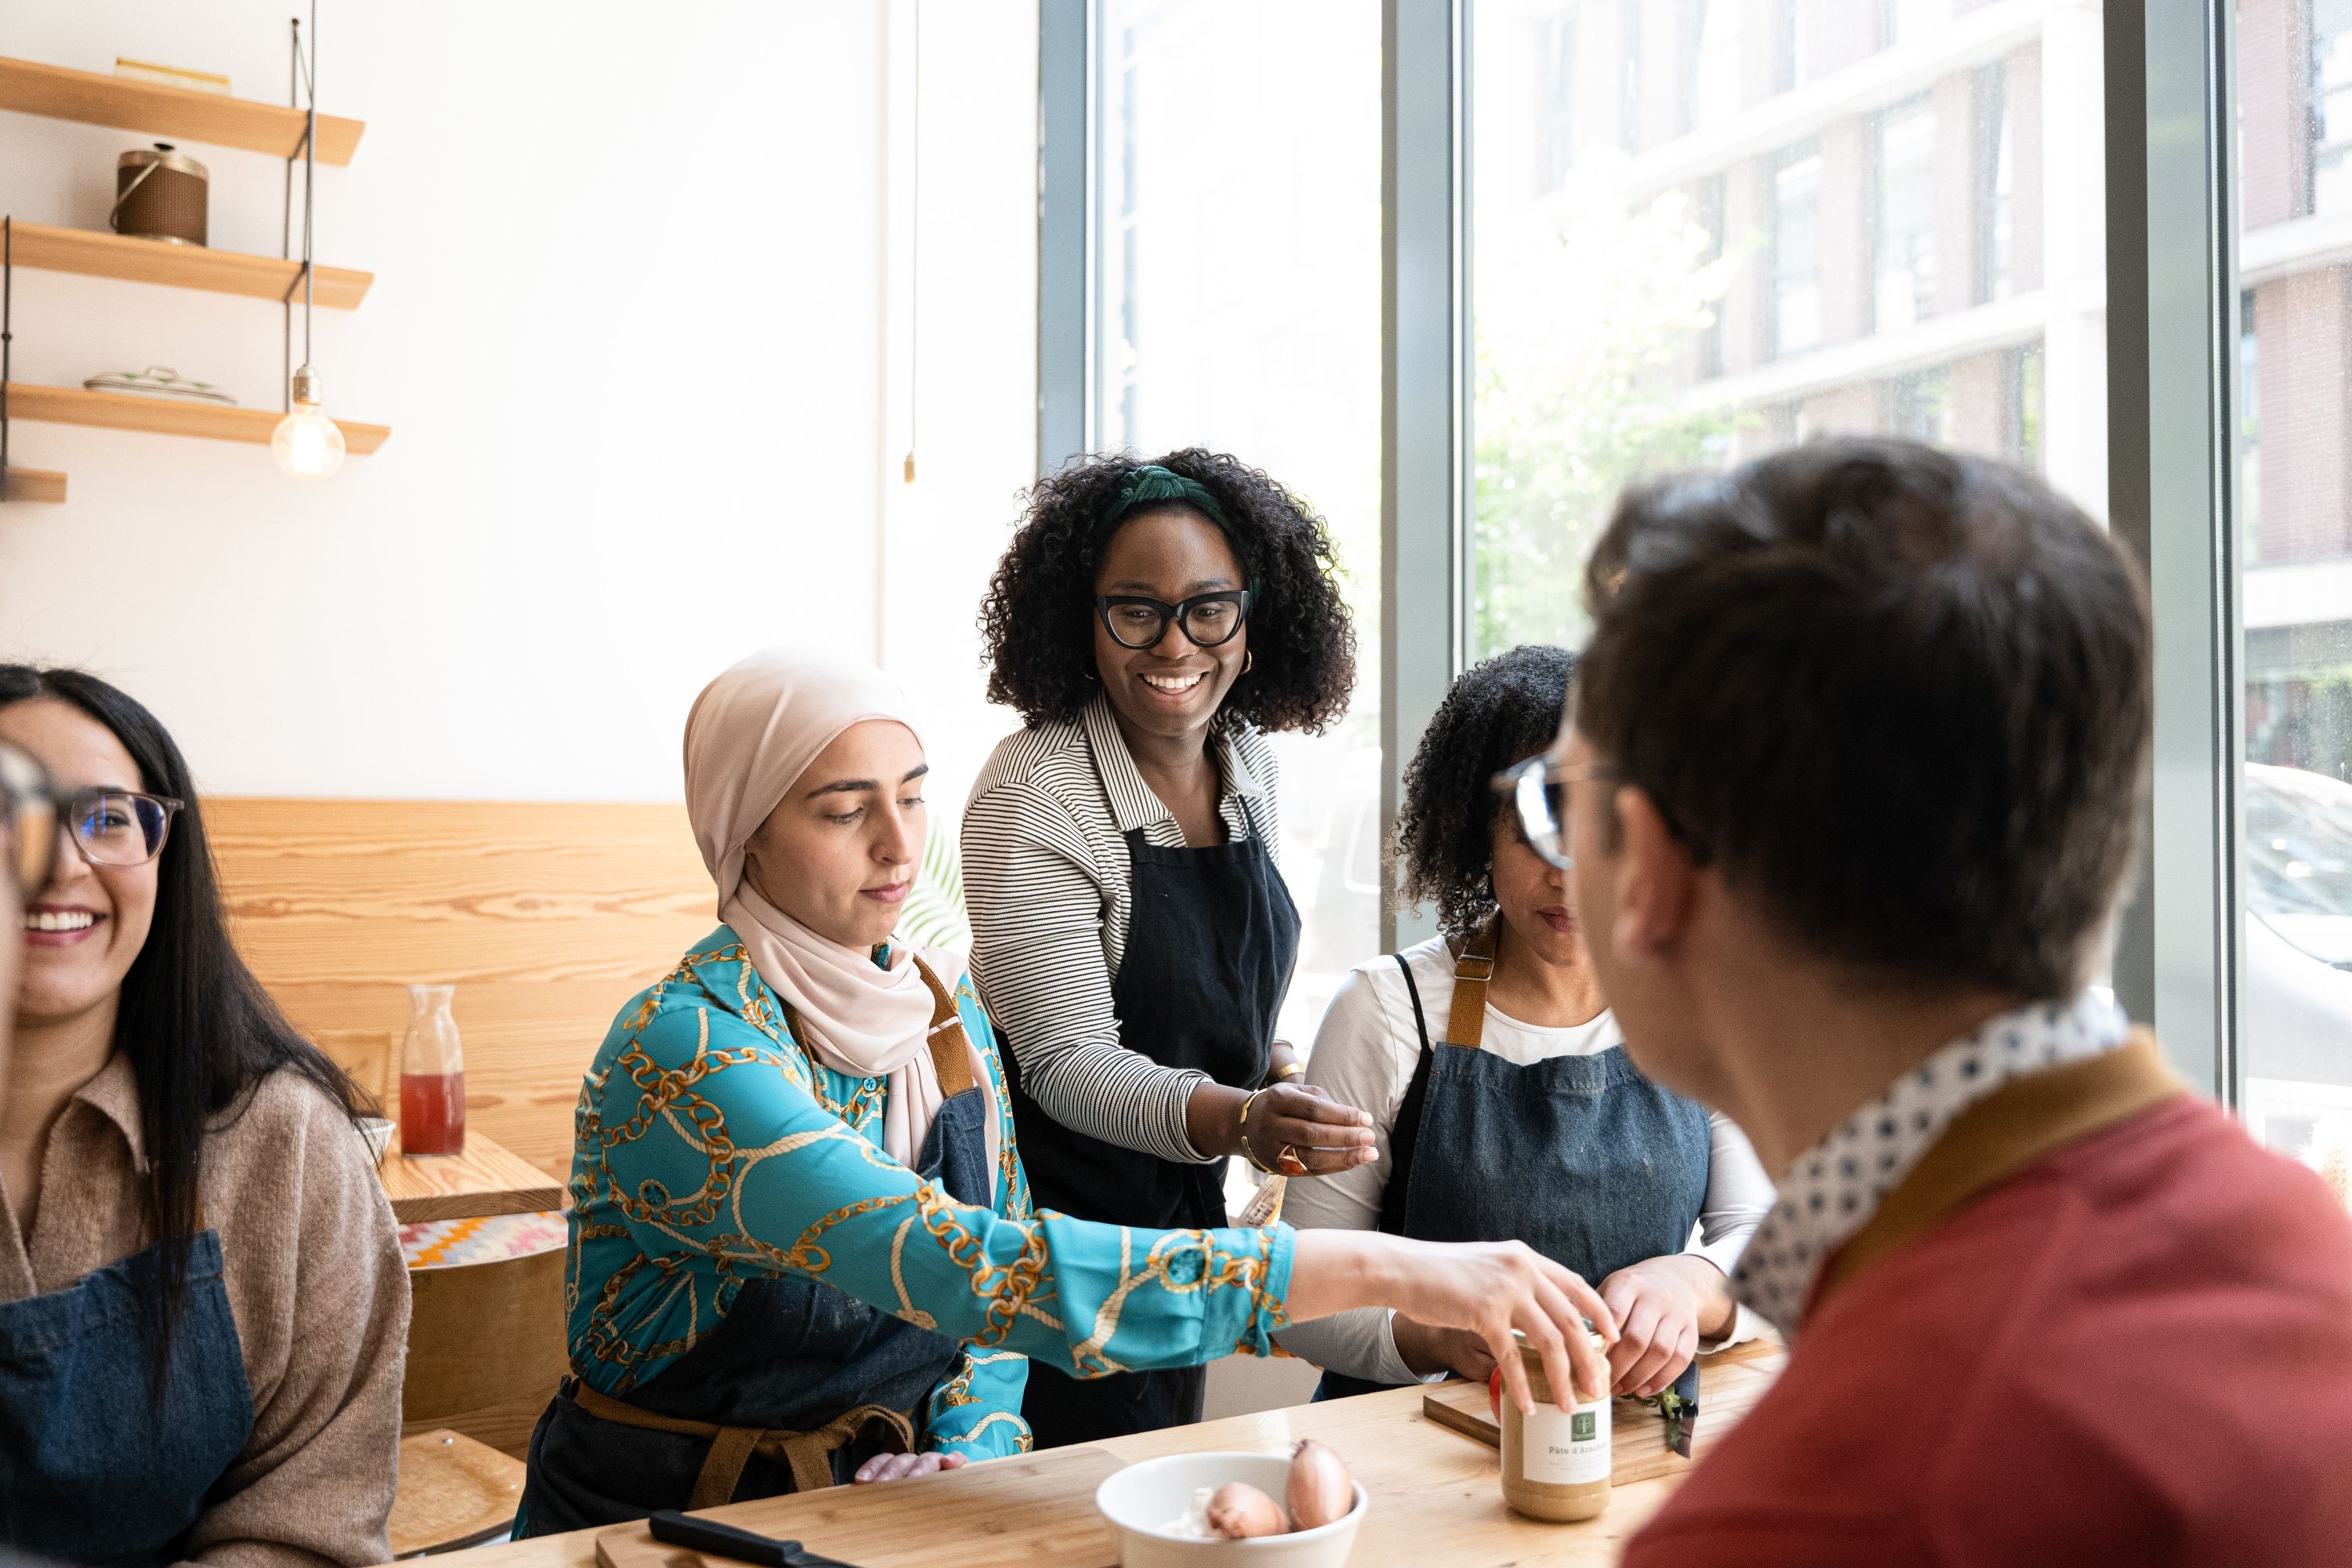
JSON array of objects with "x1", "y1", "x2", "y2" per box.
[{"x1": 1625, "y1": 1095, "x2": 2352, "y2": 1568}]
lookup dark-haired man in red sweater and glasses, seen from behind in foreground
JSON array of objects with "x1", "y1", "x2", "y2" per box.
[{"x1": 1508, "y1": 440, "x2": 2352, "y2": 1568}]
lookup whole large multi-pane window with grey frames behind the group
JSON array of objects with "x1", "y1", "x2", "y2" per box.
[{"x1": 1047, "y1": 0, "x2": 2352, "y2": 1189}]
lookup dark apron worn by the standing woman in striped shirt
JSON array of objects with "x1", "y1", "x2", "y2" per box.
[{"x1": 1014, "y1": 771, "x2": 1298, "y2": 1448}]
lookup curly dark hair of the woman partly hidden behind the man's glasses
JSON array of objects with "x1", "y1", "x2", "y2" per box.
[{"x1": 1397, "y1": 642, "x2": 1576, "y2": 938}]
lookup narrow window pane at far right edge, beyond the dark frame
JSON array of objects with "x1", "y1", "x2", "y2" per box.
[{"x1": 2237, "y1": 0, "x2": 2352, "y2": 1201}]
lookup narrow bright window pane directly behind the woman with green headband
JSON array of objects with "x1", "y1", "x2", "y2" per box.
[{"x1": 1096, "y1": 0, "x2": 1383, "y2": 1062}]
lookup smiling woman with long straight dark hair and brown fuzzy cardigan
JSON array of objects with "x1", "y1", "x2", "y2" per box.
[{"x1": 0, "y1": 666, "x2": 409, "y2": 1563}]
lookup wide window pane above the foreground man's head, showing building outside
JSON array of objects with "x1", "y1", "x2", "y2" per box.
[{"x1": 1472, "y1": 0, "x2": 2117, "y2": 654}]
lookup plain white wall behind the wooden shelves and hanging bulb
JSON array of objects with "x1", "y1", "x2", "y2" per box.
[{"x1": 0, "y1": 0, "x2": 1035, "y2": 804}]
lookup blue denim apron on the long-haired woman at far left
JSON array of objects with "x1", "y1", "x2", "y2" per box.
[{"x1": 0, "y1": 1229, "x2": 254, "y2": 1568}]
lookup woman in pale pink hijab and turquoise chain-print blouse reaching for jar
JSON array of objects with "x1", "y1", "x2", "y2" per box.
[{"x1": 522, "y1": 649, "x2": 1609, "y2": 1535}]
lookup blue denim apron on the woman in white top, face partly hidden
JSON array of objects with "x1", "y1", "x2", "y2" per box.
[{"x1": 1317, "y1": 924, "x2": 1712, "y2": 1401}]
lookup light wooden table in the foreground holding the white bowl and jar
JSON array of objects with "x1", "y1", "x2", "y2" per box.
[{"x1": 442, "y1": 1347, "x2": 1778, "y2": 1568}]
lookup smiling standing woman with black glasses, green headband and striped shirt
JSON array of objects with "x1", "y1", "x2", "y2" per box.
[{"x1": 962, "y1": 449, "x2": 1371, "y2": 1446}]
